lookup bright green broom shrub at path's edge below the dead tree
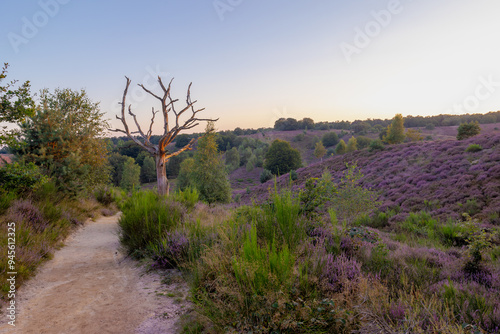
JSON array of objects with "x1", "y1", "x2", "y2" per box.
[{"x1": 119, "y1": 191, "x2": 184, "y2": 257}]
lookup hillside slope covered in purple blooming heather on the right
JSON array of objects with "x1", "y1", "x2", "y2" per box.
[{"x1": 241, "y1": 134, "x2": 500, "y2": 223}]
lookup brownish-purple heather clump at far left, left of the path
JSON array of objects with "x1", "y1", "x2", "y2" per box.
[{"x1": 7, "y1": 200, "x2": 50, "y2": 232}]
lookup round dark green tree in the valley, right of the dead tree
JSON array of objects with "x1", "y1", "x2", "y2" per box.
[{"x1": 264, "y1": 139, "x2": 302, "y2": 175}]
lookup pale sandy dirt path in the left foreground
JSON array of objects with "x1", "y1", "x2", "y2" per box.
[{"x1": 0, "y1": 216, "x2": 188, "y2": 334}]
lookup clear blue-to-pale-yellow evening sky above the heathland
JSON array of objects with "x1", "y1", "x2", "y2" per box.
[{"x1": 0, "y1": 0, "x2": 500, "y2": 131}]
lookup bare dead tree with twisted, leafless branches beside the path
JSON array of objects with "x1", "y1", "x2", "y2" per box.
[{"x1": 112, "y1": 77, "x2": 218, "y2": 196}]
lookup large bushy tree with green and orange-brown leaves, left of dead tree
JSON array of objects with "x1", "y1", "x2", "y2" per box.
[{"x1": 14, "y1": 89, "x2": 109, "y2": 194}]
